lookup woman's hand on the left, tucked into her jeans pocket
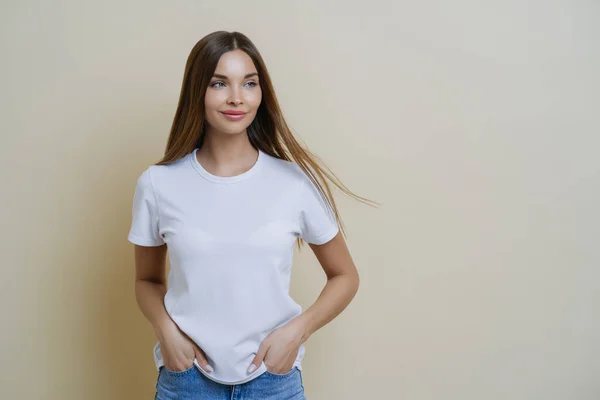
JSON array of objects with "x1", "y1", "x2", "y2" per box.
[{"x1": 159, "y1": 322, "x2": 213, "y2": 372}]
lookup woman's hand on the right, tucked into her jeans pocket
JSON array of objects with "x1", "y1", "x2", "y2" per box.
[{"x1": 248, "y1": 323, "x2": 304, "y2": 374}]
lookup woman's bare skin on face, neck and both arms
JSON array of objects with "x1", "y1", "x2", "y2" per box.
[{"x1": 134, "y1": 50, "x2": 359, "y2": 374}]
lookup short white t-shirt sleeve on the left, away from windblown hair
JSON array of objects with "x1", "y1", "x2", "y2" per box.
[{"x1": 127, "y1": 169, "x2": 165, "y2": 246}]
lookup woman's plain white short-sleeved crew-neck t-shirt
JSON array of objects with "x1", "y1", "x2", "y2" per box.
[{"x1": 128, "y1": 148, "x2": 338, "y2": 384}]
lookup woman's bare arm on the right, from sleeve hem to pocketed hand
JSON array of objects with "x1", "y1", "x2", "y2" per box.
[{"x1": 251, "y1": 232, "x2": 359, "y2": 373}]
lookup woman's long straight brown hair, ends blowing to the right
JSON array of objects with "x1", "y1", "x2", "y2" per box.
[{"x1": 156, "y1": 31, "x2": 378, "y2": 246}]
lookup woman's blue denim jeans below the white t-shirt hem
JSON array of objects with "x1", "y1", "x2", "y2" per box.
[{"x1": 154, "y1": 364, "x2": 306, "y2": 400}]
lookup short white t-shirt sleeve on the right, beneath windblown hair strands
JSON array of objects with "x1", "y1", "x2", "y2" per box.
[{"x1": 300, "y1": 176, "x2": 339, "y2": 244}]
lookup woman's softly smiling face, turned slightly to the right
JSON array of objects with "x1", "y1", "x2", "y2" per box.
[{"x1": 204, "y1": 50, "x2": 262, "y2": 134}]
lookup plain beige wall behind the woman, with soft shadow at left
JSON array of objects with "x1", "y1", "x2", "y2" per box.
[{"x1": 0, "y1": 0, "x2": 600, "y2": 400}]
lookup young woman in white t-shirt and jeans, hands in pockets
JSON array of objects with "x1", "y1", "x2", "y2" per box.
[{"x1": 128, "y1": 31, "x2": 370, "y2": 400}]
